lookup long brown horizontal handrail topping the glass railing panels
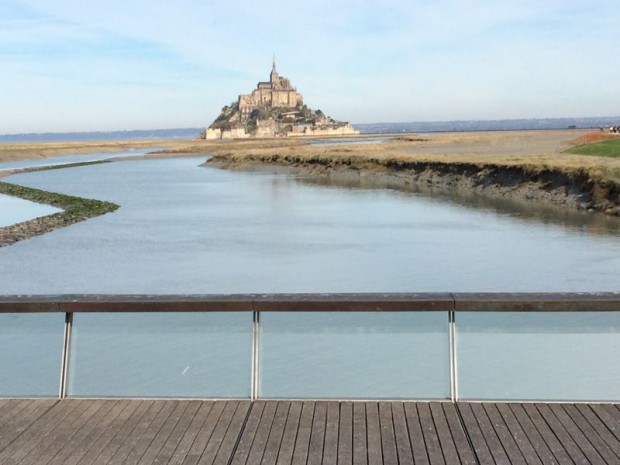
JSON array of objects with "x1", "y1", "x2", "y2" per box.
[{"x1": 0, "y1": 292, "x2": 620, "y2": 313}]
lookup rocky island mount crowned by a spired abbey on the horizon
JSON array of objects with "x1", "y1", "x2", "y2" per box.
[{"x1": 202, "y1": 60, "x2": 359, "y2": 139}]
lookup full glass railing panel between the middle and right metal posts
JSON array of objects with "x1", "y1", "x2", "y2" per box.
[{"x1": 259, "y1": 312, "x2": 450, "y2": 399}]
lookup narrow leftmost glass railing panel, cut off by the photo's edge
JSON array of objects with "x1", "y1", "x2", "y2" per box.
[{"x1": 0, "y1": 313, "x2": 65, "y2": 397}]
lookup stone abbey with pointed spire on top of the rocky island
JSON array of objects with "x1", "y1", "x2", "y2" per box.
[{"x1": 238, "y1": 59, "x2": 304, "y2": 123}]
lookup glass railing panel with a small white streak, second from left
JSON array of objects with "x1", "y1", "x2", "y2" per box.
[{"x1": 68, "y1": 312, "x2": 252, "y2": 398}]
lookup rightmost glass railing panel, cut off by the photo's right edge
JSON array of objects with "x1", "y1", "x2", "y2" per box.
[{"x1": 456, "y1": 312, "x2": 620, "y2": 401}]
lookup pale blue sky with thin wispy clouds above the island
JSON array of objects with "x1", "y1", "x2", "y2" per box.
[{"x1": 0, "y1": 0, "x2": 620, "y2": 134}]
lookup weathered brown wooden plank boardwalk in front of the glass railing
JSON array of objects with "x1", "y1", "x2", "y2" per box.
[{"x1": 0, "y1": 399, "x2": 620, "y2": 465}]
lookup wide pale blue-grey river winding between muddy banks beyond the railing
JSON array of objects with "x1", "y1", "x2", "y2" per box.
[{"x1": 0, "y1": 157, "x2": 620, "y2": 294}]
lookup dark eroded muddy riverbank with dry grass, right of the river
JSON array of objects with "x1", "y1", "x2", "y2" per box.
[{"x1": 207, "y1": 154, "x2": 620, "y2": 216}]
